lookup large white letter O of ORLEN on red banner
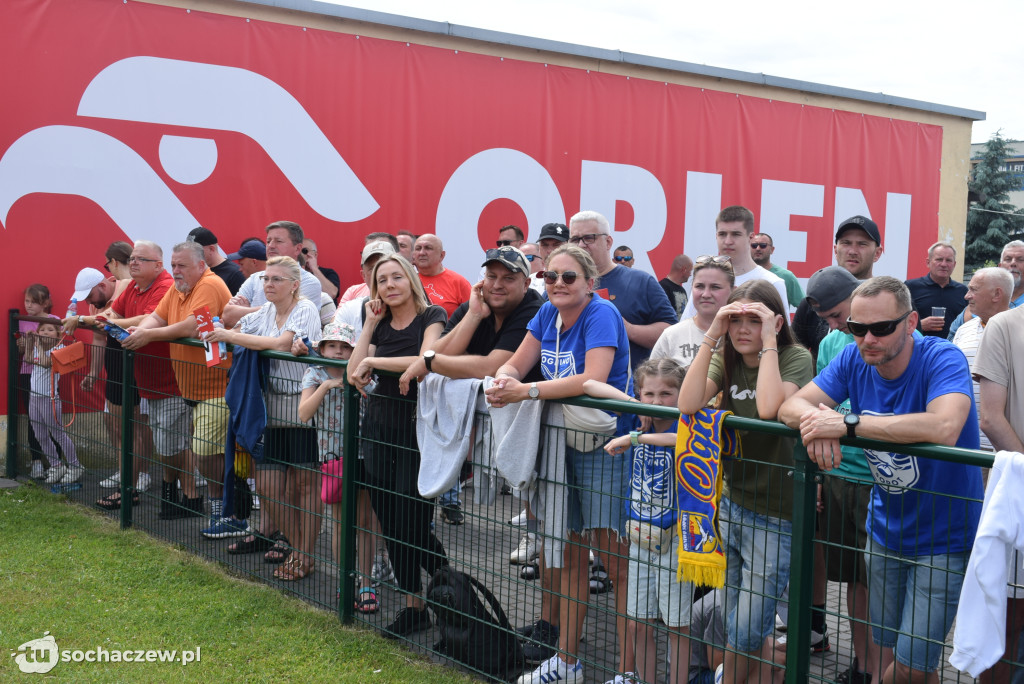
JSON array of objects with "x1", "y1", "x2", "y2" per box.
[{"x1": 434, "y1": 147, "x2": 565, "y2": 283}]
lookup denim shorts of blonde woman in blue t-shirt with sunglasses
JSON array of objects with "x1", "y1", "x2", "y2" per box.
[{"x1": 565, "y1": 444, "x2": 630, "y2": 535}]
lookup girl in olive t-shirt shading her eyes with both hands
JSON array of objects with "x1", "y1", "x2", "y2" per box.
[{"x1": 679, "y1": 281, "x2": 814, "y2": 683}]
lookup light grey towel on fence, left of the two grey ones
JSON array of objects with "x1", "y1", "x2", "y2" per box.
[{"x1": 416, "y1": 373, "x2": 483, "y2": 499}]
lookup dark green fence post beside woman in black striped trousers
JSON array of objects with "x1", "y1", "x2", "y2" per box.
[{"x1": 336, "y1": 370, "x2": 361, "y2": 624}]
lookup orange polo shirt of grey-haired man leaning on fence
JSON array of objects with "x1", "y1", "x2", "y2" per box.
[{"x1": 154, "y1": 268, "x2": 231, "y2": 401}]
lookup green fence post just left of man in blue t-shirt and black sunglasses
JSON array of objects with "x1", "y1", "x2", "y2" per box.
[{"x1": 785, "y1": 439, "x2": 820, "y2": 684}]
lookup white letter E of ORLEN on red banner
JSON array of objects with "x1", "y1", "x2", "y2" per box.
[{"x1": 757, "y1": 178, "x2": 825, "y2": 268}]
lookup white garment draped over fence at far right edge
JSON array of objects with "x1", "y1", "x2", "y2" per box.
[{"x1": 949, "y1": 452, "x2": 1024, "y2": 677}]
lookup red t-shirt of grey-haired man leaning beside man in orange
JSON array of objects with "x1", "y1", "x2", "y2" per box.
[{"x1": 111, "y1": 270, "x2": 180, "y2": 399}]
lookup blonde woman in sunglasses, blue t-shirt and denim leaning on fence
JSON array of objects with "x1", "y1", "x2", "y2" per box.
[{"x1": 487, "y1": 245, "x2": 630, "y2": 679}]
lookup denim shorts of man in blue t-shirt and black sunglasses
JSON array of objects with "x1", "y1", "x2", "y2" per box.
[{"x1": 866, "y1": 537, "x2": 968, "y2": 672}]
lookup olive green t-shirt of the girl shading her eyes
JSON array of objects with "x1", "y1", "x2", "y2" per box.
[{"x1": 708, "y1": 344, "x2": 814, "y2": 520}]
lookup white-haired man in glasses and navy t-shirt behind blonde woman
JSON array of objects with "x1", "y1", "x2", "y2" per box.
[{"x1": 569, "y1": 211, "x2": 677, "y2": 368}]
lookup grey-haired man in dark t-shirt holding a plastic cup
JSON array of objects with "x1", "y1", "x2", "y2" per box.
[{"x1": 906, "y1": 242, "x2": 967, "y2": 338}]
